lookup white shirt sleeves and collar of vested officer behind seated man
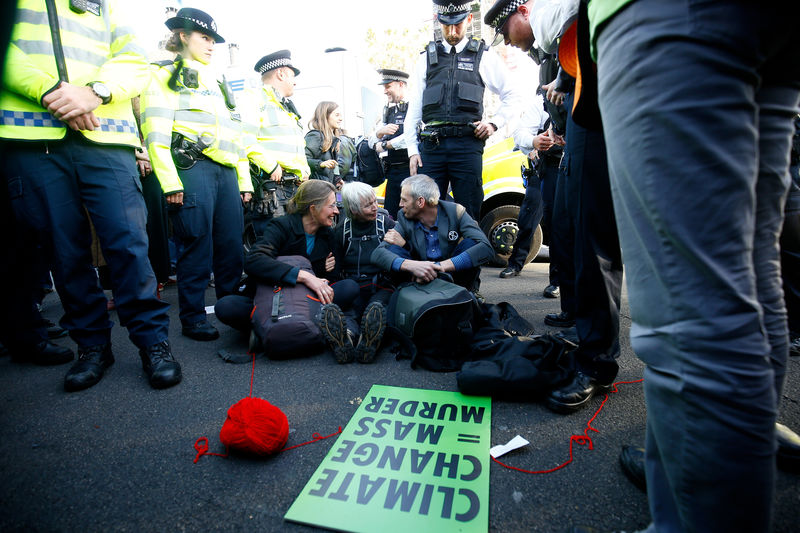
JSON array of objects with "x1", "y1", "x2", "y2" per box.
[{"x1": 400, "y1": 38, "x2": 523, "y2": 157}]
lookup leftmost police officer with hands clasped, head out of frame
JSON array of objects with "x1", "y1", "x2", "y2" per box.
[{"x1": 0, "y1": 0, "x2": 181, "y2": 391}]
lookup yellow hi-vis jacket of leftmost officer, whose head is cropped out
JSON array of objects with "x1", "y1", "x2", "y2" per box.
[{"x1": 0, "y1": 0, "x2": 150, "y2": 147}]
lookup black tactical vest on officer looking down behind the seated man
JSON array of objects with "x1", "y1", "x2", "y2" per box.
[{"x1": 422, "y1": 39, "x2": 486, "y2": 124}]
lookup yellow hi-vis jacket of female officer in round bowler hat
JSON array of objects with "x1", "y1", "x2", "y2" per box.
[{"x1": 141, "y1": 59, "x2": 253, "y2": 194}]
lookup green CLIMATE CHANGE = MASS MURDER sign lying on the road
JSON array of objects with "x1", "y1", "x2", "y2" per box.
[{"x1": 284, "y1": 385, "x2": 492, "y2": 533}]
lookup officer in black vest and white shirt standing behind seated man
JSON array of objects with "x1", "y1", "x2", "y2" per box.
[{"x1": 403, "y1": 0, "x2": 522, "y2": 220}]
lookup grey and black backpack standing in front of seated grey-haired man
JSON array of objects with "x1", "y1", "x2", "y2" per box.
[{"x1": 387, "y1": 278, "x2": 478, "y2": 372}]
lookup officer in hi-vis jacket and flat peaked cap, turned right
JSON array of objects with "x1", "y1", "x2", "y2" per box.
[{"x1": 244, "y1": 50, "x2": 311, "y2": 236}]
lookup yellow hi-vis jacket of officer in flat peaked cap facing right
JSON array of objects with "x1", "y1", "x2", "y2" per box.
[{"x1": 244, "y1": 85, "x2": 311, "y2": 178}]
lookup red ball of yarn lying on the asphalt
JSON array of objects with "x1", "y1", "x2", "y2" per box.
[{"x1": 219, "y1": 396, "x2": 289, "y2": 455}]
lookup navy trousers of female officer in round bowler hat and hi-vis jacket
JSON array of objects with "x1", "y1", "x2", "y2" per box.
[{"x1": 169, "y1": 159, "x2": 244, "y2": 326}]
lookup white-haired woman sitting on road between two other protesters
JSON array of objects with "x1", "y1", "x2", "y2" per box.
[{"x1": 333, "y1": 181, "x2": 395, "y2": 363}]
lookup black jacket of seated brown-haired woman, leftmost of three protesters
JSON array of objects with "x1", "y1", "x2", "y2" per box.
[{"x1": 244, "y1": 213, "x2": 335, "y2": 285}]
